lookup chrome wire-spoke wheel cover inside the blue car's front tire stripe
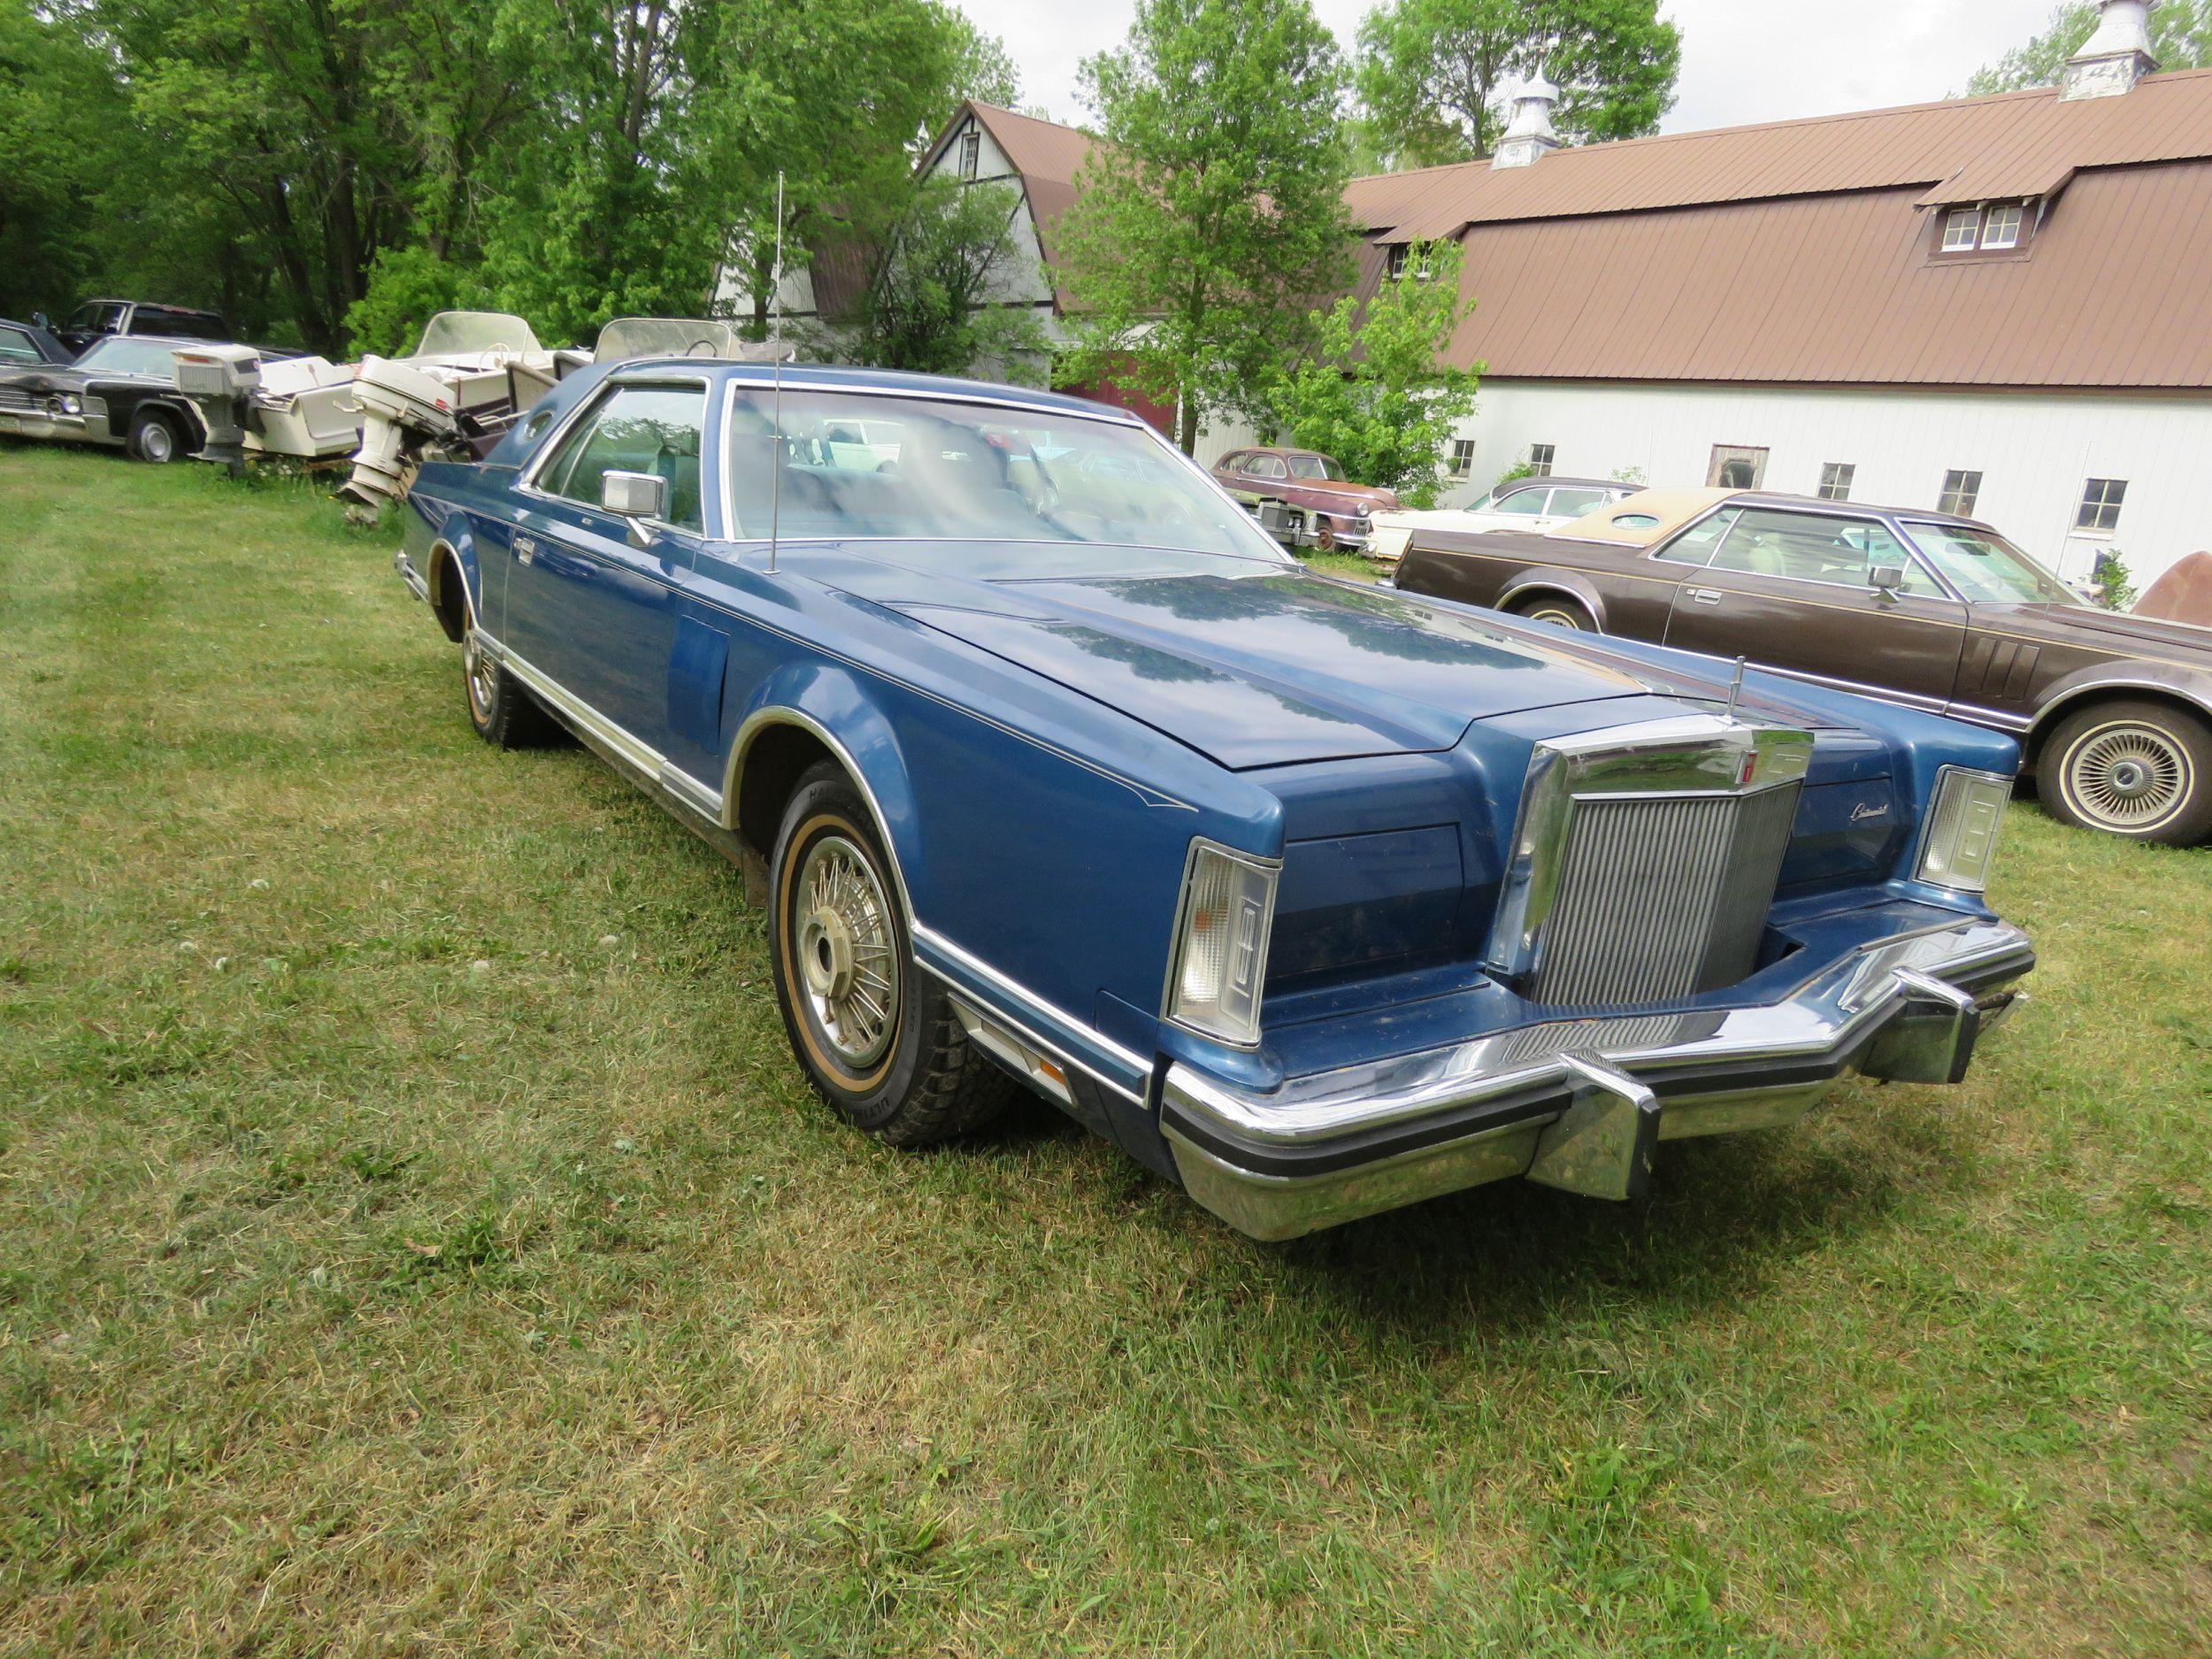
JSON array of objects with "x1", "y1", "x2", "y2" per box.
[{"x1": 792, "y1": 834, "x2": 901, "y2": 1071}]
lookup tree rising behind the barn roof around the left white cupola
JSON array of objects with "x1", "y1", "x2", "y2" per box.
[{"x1": 1358, "y1": 0, "x2": 1681, "y2": 166}]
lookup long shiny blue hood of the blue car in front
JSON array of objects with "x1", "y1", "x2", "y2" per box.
[{"x1": 863, "y1": 559, "x2": 1796, "y2": 770}]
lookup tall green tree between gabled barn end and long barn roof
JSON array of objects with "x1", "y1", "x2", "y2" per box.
[{"x1": 1060, "y1": 0, "x2": 1352, "y2": 454}]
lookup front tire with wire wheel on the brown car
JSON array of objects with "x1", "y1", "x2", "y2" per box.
[{"x1": 2038, "y1": 699, "x2": 2212, "y2": 848}]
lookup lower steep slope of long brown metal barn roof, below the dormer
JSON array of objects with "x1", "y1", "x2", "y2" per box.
[{"x1": 1451, "y1": 159, "x2": 2212, "y2": 389}]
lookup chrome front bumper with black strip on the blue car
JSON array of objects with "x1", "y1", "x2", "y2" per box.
[{"x1": 1162, "y1": 923, "x2": 2035, "y2": 1239}]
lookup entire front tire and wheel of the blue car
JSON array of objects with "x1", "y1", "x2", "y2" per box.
[{"x1": 768, "y1": 761, "x2": 1016, "y2": 1146}]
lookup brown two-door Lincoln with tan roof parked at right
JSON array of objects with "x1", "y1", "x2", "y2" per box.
[{"x1": 1398, "y1": 489, "x2": 2212, "y2": 845}]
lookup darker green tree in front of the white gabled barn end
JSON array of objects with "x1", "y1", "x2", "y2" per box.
[{"x1": 845, "y1": 177, "x2": 1048, "y2": 380}]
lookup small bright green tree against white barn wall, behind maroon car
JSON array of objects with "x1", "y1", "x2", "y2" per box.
[{"x1": 1270, "y1": 243, "x2": 1480, "y2": 507}]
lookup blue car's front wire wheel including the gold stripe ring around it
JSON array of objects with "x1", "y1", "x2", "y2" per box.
[{"x1": 777, "y1": 812, "x2": 905, "y2": 1095}]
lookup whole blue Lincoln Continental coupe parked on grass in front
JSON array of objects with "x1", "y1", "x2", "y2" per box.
[{"x1": 398, "y1": 358, "x2": 2035, "y2": 1239}]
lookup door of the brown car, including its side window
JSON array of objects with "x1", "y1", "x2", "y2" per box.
[{"x1": 1666, "y1": 507, "x2": 1967, "y2": 708}]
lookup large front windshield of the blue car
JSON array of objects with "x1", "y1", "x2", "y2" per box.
[{"x1": 730, "y1": 385, "x2": 1286, "y2": 573}]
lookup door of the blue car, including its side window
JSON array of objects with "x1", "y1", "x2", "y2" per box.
[{"x1": 504, "y1": 374, "x2": 706, "y2": 750}]
